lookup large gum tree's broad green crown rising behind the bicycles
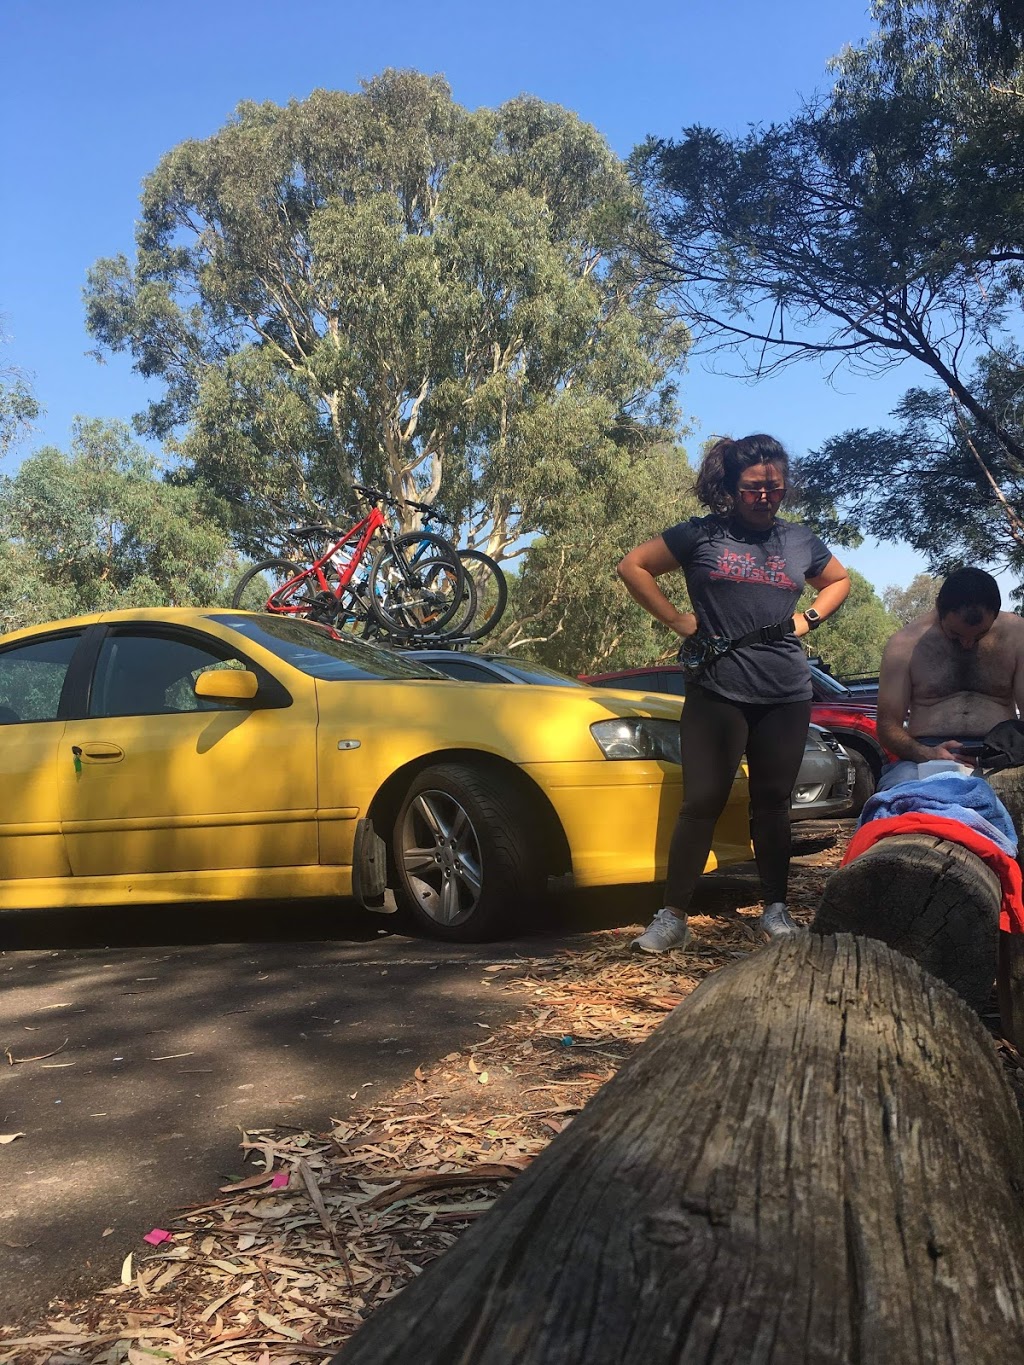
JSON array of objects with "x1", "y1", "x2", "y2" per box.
[{"x1": 86, "y1": 71, "x2": 688, "y2": 554}]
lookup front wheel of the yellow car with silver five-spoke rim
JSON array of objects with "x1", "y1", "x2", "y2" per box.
[{"x1": 392, "y1": 763, "x2": 546, "y2": 943}]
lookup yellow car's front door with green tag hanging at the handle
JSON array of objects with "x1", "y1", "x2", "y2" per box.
[{"x1": 59, "y1": 624, "x2": 318, "y2": 894}]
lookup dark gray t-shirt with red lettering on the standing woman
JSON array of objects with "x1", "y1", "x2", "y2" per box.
[{"x1": 662, "y1": 516, "x2": 831, "y2": 702}]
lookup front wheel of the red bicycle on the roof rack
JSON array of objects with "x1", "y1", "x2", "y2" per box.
[{"x1": 367, "y1": 531, "x2": 464, "y2": 637}]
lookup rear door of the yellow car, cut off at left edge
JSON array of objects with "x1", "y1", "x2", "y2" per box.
[{"x1": 0, "y1": 631, "x2": 82, "y2": 882}]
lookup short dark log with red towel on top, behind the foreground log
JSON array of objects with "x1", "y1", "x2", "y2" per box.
[{"x1": 811, "y1": 834, "x2": 1002, "y2": 1013}]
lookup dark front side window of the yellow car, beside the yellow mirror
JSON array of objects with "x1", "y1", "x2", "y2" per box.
[{"x1": 89, "y1": 631, "x2": 246, "y2": 717}]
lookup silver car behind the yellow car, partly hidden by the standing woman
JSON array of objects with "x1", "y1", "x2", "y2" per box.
[{"x1": 408, "y1": 650, "x2": 856, "y2": 820}]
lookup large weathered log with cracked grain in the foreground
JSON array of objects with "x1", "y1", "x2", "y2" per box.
[{"x1": 335, "y1": 935, "x2": 1024, "y2": 1365}]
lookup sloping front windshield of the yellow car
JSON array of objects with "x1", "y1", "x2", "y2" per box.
[{"x1": 210, "y1": 612, "x2": 440, "y2": 683}]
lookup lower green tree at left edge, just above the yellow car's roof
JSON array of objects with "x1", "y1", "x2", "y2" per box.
[{"x1": 0, "y1": 420, "x2": 236, "y2": 631}]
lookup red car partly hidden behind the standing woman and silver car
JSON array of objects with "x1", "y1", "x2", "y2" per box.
[{"x1": 580, "y1": 663, "x2": 889, "y2": 815}]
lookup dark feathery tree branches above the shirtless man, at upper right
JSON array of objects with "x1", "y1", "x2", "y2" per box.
[{"x1": 635, "y1": 0, "x2": 1024, "y2": 568}]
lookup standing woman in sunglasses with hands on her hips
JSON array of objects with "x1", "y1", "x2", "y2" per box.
[{"x1": 618, "y1": 435, "x2": 849, "y2": 953}]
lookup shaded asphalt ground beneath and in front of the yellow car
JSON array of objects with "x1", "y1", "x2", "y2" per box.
[{"x1": 0, "y1": 889, "x2": 682, "y2": 1324}]
